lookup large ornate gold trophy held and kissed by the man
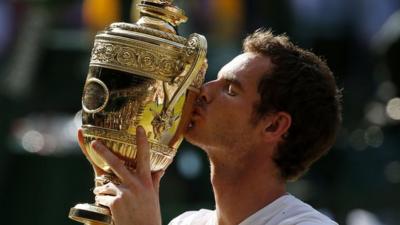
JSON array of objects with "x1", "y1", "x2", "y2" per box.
[{"x1": 69, "y1": 0, "x2": 207, "y2": 224}]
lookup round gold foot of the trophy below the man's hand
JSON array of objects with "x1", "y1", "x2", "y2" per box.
[{"x1": 69, "y1": 203, "x2": 113, "y2": 225}]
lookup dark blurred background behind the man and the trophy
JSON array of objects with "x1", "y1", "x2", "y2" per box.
[{"x1": 0, "y1": 0, "x2": 400, "y2": 225}]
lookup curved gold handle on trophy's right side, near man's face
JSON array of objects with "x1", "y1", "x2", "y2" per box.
[{"x1": 165, "y1": 33, "x2": 207, "y2": 112}]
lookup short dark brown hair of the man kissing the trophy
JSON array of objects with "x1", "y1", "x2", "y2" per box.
[{"x1": 243, "y1": 29, "x2": 341, "y2": 180}]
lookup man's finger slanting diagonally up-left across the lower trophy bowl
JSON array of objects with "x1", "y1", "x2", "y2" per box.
[{"x1": 91, "y1": 140, "x2": 132, "y2": 182}]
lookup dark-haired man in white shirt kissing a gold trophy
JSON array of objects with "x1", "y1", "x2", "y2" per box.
[{"x1": 78, "y1": 30, "x2": 341, "y2": 225}]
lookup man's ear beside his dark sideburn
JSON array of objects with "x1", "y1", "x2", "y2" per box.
[{"x1": 263, "y1": 112, "x2": 292, "y2": 141}]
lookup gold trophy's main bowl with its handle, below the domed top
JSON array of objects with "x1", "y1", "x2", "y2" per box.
[{"x1": 82, "y1": 27, "x2": 206, "y2": 171}]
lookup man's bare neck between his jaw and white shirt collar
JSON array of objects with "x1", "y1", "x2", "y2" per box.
[{"x1": 210, "y1": 149, "x2": 286, "y2": 225}]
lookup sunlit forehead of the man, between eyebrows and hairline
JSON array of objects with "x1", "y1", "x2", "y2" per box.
[{"x1": 218, "y1": 52, "x2": 271, "y2": 81}]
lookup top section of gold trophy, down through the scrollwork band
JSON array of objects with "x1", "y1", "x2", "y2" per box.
[{"x1": 90, "y1": 0, "x2": 207, "y2": 82}]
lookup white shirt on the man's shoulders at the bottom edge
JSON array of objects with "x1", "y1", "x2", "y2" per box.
[{"x1": 169, "y1": 194, "x2": 338, "y2": 225}]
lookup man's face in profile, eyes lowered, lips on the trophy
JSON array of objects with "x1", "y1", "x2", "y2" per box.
[{"x1": 185, "y1": 53, "x2": 271, "y2": 155}]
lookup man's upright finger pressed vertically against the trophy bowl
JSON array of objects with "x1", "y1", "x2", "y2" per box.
[{"x1": 136, "y1": 126, "x2": 150, "y2": 177}]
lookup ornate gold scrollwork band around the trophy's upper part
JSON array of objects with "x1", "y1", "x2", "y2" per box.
[{"x1": 90, "y1": 34, "x2": 182, "y2": 81}]
